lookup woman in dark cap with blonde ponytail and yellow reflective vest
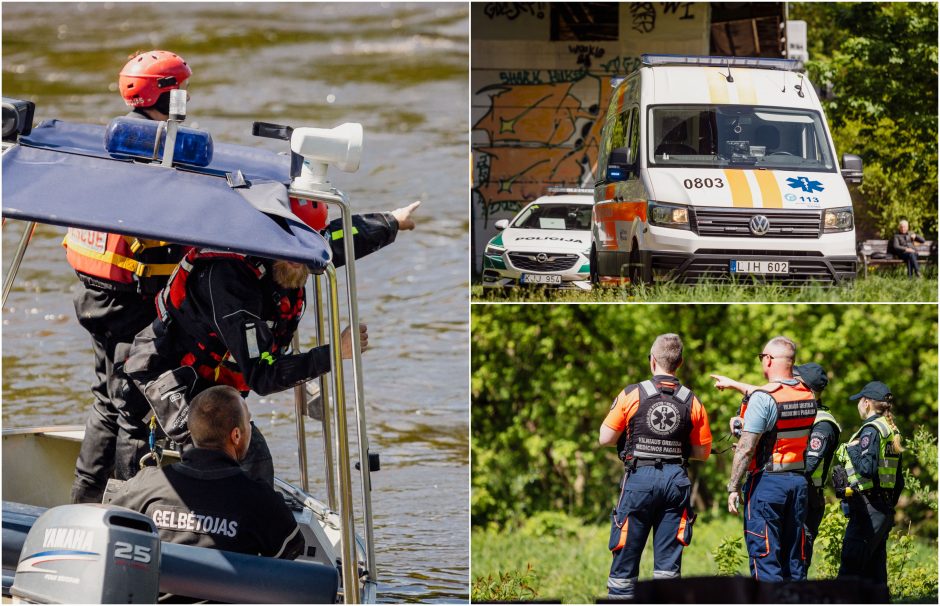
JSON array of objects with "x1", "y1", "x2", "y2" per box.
[{"x1": 836, "y1": 381, "x2": 904, "y2": 584}]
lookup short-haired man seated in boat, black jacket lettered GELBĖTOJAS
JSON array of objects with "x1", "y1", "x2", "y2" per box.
[{"x1": 111, "y1": 385, "x2": 304, "y2": 560}]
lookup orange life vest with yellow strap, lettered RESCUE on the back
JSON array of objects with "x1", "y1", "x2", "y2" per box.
[{"x1": 62, "y1": 227, "x2": 187, "y2": 294}]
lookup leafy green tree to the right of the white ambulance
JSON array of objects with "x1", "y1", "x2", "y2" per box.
[{"x1": 790, "y1": 2, "x2": 937, "y2": 238}]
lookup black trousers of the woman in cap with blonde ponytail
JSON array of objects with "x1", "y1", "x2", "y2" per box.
[{"x1": 839, "y1": 492, "x2": 894, "y2": 584}]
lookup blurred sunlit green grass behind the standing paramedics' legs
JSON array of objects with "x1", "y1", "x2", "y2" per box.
[{"x1": 471, "y1": 515, "x2": 937, "y2": 604}]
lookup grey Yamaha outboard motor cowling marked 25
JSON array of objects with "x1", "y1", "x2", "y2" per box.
[{"x1": 10, "y1": 505, "x2": 160, "y2": 604}]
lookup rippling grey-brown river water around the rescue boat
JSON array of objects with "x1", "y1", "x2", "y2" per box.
[{"x1": 2, "y1": 3, "x2": 469, "y2": 602}]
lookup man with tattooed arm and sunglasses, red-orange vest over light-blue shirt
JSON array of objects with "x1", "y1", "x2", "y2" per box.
[{"x1": 728, "y1": 337, "x2": 817, "y2": 581}]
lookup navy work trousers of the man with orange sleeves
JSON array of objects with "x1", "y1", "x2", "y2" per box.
[{"x1": 607, "y1": 464, "x2": 694, "y2": 598}]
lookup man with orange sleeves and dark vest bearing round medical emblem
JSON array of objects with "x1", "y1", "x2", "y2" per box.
[{"x1": 599, "y1": 334, "x2": 712, "y2": 599}]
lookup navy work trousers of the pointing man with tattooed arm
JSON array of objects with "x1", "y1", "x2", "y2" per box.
[{"x1": 744, "y1": 471, "x2": 807, "y2": 581}]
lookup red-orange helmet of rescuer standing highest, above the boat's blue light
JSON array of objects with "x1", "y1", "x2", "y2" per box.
[{"x1": 118, "y1": 50, "x2": 193, "y2": 107}]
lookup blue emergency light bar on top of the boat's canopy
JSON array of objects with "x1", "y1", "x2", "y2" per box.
[{"x1": 104, "y1": 118, "x2": 212, "y2": 166}]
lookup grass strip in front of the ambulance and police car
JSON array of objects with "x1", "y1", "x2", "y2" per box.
[{"x1": 471, "y1": 272, "x2": 938, "y2": 303}]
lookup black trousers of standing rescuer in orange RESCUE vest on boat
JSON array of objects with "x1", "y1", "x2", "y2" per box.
[{"x1": 72, "y1": 283, "x2": 157, "y2": 503}]
